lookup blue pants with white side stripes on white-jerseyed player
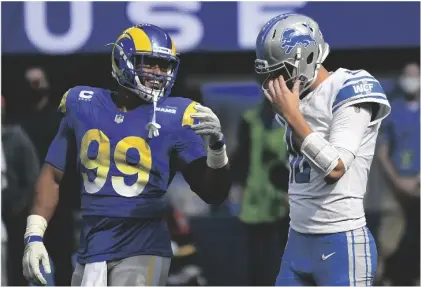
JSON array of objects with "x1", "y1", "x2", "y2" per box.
[{"x1": 277, "y1": 226, "x2": 377, "y2": 286}]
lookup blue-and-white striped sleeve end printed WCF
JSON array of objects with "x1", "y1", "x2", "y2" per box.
[{"x1": 332, "y1": 75, "x2": 387, "y2": 113}]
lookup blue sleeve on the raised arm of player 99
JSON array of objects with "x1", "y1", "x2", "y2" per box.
[{"x1": 175, "y1": 126, "x2": 207, "y2": 168}]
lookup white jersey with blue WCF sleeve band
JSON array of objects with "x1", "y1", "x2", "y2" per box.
[{"x1": 276, "y1": 68, "x2": 390, "y2": 234}]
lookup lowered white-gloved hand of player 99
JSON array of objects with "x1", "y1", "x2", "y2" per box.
[{"x1": 22, "y1": 241, "x2": 51, "y2": 285}]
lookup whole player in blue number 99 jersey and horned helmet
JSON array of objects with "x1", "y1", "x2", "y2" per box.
[{"x1": 23, "y1": 24, "x2": 231, "y2": 286}]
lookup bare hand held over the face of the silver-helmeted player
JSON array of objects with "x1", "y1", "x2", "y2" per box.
[{"x1": 264, "y1": 76, "x2": 300, "y2": 118}]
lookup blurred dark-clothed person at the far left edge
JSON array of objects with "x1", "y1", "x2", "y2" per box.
[{"x1": 1, "y1": 97, "x2": 40, "y2": 286}]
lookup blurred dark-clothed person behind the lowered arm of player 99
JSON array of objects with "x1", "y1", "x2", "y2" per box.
[{"x1": 19, "y1": 67, "x2": 79, "y2": 286}]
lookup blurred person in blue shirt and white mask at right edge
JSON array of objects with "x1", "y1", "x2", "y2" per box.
[{"x1": 378, "y1": 63, "x2": 420, "y2": 285}]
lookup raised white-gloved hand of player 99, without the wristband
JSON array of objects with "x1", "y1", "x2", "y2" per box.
[{"x1": 191, "y1": 104, "x2": 224, "y2": 147}]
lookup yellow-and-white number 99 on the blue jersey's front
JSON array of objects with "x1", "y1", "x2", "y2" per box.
[{"x1": 80, "y1": 129, "x2": 152, "y2": 197}]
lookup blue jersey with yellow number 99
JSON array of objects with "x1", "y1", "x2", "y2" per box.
[{"x1": 45, "y1": 86, "x2": 206, "y2": 263}]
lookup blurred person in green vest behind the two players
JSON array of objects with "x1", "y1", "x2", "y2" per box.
[{"x1": 233, "y1": 99, "x2": 289, "y2": 286}]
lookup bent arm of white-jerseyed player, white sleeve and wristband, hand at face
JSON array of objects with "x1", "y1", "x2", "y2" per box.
[{"x1": 265, "y1": 82, "x2": 372, "y2": 184}]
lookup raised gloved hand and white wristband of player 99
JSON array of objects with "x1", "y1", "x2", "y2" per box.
[{"x1": 191, "y1": 104, "x2": 228, "y2": 169}]
